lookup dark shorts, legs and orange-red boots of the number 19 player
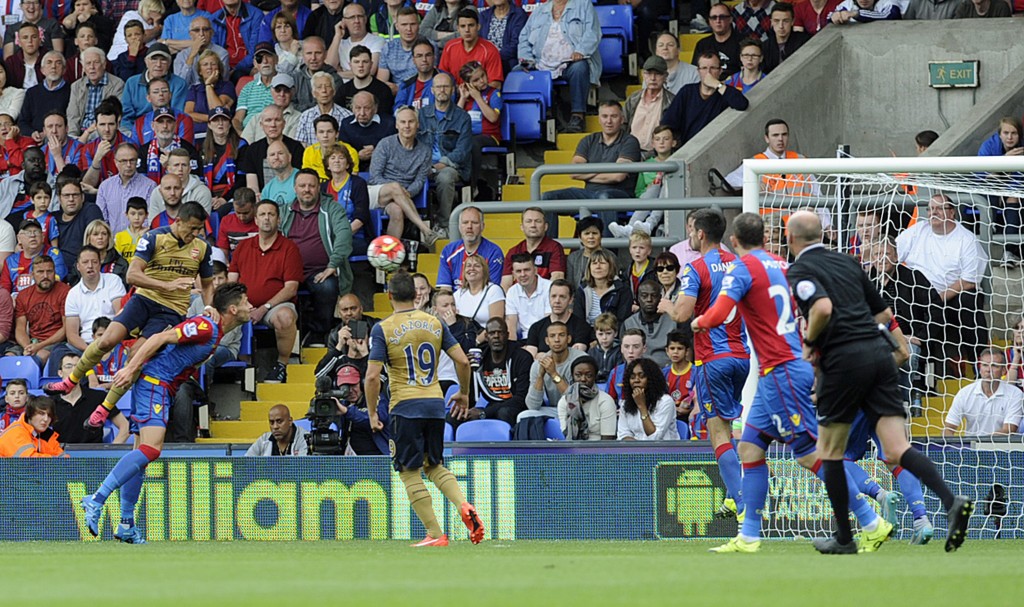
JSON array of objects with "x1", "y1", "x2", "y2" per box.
[{"x1": 391, "y1": 416, "x2": 484, "y2": 548}]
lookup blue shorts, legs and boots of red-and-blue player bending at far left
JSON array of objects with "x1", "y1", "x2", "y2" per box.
[{"x1": 82, "y1": 381, "x2": 173, "y2": 544}]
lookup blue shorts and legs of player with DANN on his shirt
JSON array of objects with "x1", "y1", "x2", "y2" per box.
[{"x1": 694, "y1": 358, "x2": 751, "y2": 522}]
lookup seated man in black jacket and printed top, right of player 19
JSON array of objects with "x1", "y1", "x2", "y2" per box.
[{"x1": 446, "y1": 316, "x2": 534, "y2": 428}]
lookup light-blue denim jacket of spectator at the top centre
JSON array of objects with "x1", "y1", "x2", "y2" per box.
[{"x1": 520, "y1": 2, "x2": 601, "y2": 86}]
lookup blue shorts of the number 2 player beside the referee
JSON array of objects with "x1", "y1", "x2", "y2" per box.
[{"x1": 743, "y1": 359, "x2": 818, "y2": 444}]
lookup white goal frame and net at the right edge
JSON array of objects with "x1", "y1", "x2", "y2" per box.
[{"x1": 743, "y1": 157, "x2": 1024, "y2": 538}]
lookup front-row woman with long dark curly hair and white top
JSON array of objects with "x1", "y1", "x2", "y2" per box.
[{"x1": 618, "y1": 358, "x2": 679, "y2": 440}]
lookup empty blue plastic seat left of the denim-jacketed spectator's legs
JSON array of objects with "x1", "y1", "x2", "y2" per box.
[{"x1": 501, "y1": 71, "x2": 552, "y2": 143}]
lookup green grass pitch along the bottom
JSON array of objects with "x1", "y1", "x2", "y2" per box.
[{"x1": 0, "y1": 539, "x2": 1024, "y2": 607}]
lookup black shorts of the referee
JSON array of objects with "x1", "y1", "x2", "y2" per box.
[{"x1": 817, "y1": 335, "x2": 906, "y2": 426}]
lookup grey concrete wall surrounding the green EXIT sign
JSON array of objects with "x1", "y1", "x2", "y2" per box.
[{"x1": 675, "y1": 19, "x2": 1024, "y2": 196}]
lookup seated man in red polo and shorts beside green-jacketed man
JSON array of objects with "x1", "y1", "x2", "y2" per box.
[{"x1": 227, "y1": 200, "x2": 303, "y2": 384}]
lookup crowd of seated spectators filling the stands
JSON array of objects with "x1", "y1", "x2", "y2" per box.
[{"x1": 0, "y1": 0, "x2": 1021, "y2": 451}]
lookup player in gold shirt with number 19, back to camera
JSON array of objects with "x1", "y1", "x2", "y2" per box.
[{"x1": 364, "y1": 271, "x2": 483, "y2": 548}]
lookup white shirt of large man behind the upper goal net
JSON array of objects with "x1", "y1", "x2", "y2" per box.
[{"x1": 896, "y1": 219, "x2": 988, "y2": 292}]
